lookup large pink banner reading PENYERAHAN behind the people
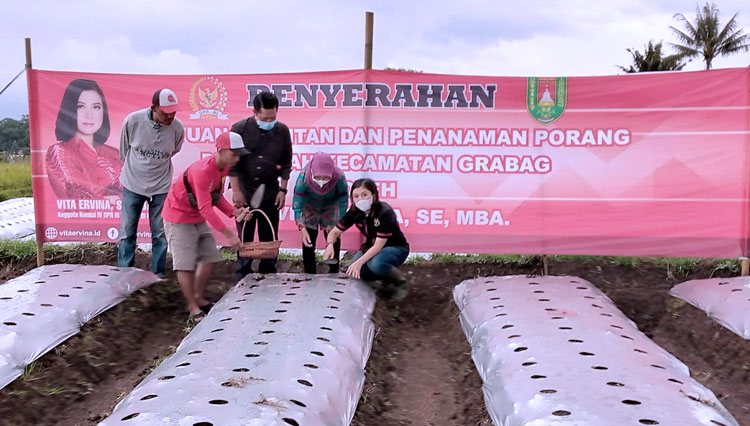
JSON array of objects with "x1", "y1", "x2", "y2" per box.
[{"x1": 29, "y1": 68, "x2": 750, "y2": 257}]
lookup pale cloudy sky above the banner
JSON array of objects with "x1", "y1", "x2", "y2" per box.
[{"x1": 0, "y1": 0, "x2": 750, "y2": 119}]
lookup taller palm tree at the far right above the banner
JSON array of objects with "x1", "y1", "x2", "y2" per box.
[{"x1": 669, "y1": 3, "x2": 750, "y2": 70}]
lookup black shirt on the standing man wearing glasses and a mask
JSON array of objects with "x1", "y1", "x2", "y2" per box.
[{"x1": 229, "y1": 117, "x2": 292, "y2": 201}]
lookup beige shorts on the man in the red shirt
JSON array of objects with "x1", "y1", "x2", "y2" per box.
[{"x1": 164, "y1": 220, "x2": 221, "y2": 271}]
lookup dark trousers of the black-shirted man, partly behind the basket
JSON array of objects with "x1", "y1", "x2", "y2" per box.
[{"x1": 237, "y1": 199, "x2": 279, "y2": 279}]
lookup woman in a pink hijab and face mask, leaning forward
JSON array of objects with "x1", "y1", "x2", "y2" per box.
[{"x1": 292, "y1": 152, "x2": 349, "y2": 274}]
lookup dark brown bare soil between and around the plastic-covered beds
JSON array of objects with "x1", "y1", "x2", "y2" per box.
[{"x1": 0, "y1": 246, "x2": 750, "y2": 426}]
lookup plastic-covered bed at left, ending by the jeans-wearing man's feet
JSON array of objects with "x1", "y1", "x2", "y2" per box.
[{"x1": 0, "y1": 265, "x2": 159, "y2": 389}]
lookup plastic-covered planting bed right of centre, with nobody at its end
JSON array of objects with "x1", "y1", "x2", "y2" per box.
[{"x1": 453, "y1": 276, "x2": 738, "y2": 426}]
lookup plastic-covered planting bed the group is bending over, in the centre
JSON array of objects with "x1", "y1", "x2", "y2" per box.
[{"x1": 100, "y1": 274, "x2": 375, "y2": 426}]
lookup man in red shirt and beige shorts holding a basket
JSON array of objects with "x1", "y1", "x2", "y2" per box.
[{"x1": 162, "y1": 132, "x2": 247, "y2": 321}]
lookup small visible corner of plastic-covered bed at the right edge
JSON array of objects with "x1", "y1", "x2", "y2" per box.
[{"x1": 669, "y1": 277, "x2": 750, "y2": 340}]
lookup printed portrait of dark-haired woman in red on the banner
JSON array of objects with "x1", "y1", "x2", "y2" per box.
[{"x1": 45, "y1": 79, "x2": 122, "y2": 199}]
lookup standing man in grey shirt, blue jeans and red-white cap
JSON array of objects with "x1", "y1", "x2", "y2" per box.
[{"x1": 117, "y1": 88, "x2": 185, "y2": 278}]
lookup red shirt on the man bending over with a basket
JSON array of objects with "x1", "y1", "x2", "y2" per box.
[{"x1": 161, "y1": 156, "x2": 234, "y2": 231}]
